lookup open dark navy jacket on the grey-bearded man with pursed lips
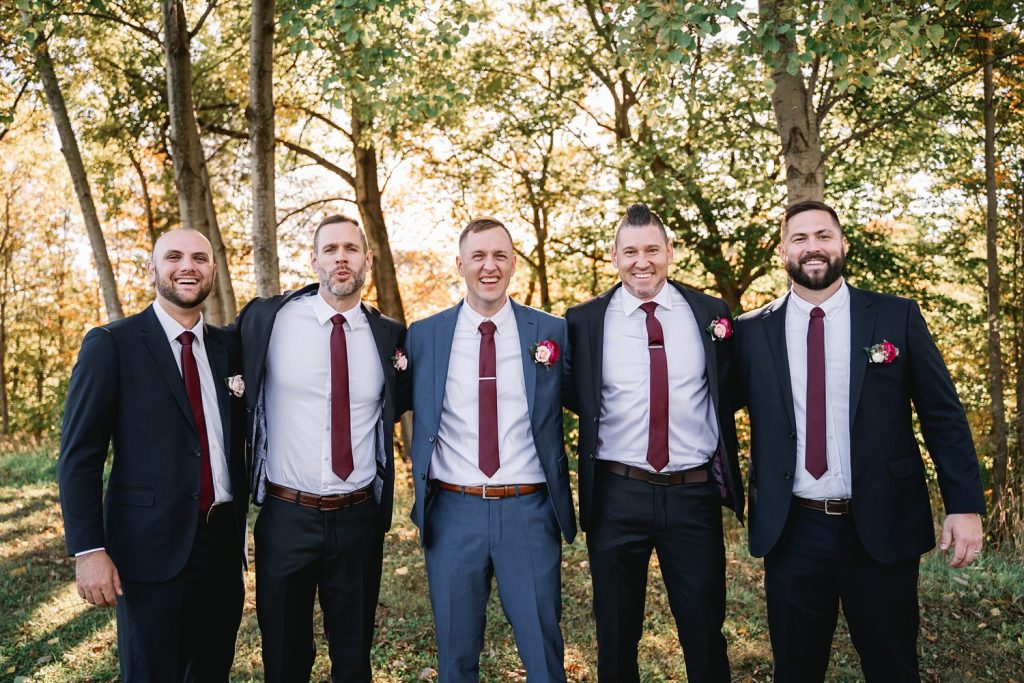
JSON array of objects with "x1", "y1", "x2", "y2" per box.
[{"x1": 231, "y1": 284, "x2": 409, "y2": 531}]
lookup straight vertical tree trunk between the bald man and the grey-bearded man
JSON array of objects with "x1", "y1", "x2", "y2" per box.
[{"x1": 246, "y1": 0, "x2": 281, "y2": 297}]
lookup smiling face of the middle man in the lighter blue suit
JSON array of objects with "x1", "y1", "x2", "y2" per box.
[{"x1": 455, "y1": 226, "x2": 515, "y2": 316}]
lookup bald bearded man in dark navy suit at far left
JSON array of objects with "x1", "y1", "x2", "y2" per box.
[{"x1": 57, "y1": 228, "x2": 249, "y2": 682}]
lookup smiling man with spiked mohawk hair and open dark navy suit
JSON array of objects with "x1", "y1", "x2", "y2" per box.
[{"x1": 565, "y1": 204, "x2": 743, "y2": 683}]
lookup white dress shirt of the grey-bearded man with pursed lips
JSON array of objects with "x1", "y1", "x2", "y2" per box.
[{"x1": 264, "y1": 292, "x2": 384, "y2": 496}]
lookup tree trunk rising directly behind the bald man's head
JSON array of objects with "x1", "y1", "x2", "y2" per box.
[{"x1": 163, "y1": 0, "x2": 234, "y2": 325}]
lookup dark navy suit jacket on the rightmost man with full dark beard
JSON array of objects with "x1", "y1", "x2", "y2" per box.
[{"x1": 736, "y1": 287, "x2": 985, "y2": 562}]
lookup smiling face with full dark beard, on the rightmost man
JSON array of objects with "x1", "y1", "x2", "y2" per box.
[{"x1": 778, "y1": 210, "x2": 846, "y2": 299}]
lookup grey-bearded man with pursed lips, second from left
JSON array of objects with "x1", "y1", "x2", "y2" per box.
[{"x1": 234, "y1": 215, "x2": 408, "y2": 683}]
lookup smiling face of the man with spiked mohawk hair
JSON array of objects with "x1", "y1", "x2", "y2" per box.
[{"x1": 611, "y1": 224, "x2": 675, "y2": 301}]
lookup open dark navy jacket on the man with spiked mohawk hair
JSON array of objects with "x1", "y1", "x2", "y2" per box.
[{"x1": 565, "y1": 280, "x2": 743, "y2": 530}]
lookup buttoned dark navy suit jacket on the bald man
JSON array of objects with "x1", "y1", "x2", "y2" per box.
[{"x1": 57, "y1": 304, "x2": 249, "y2": 582}]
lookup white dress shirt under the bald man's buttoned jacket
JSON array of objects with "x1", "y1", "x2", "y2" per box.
[{"x1": 153, "y1": 300, "x2": 232, "y2": 505}]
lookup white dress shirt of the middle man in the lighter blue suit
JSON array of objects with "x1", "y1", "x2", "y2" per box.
[{"x1": 430, "y1": 299, "x2": 557, "y2": 486}]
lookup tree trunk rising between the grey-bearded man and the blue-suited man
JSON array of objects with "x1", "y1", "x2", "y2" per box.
[{"x1": 351, "y1": 105, "x2": 406, "y2": 324}]
